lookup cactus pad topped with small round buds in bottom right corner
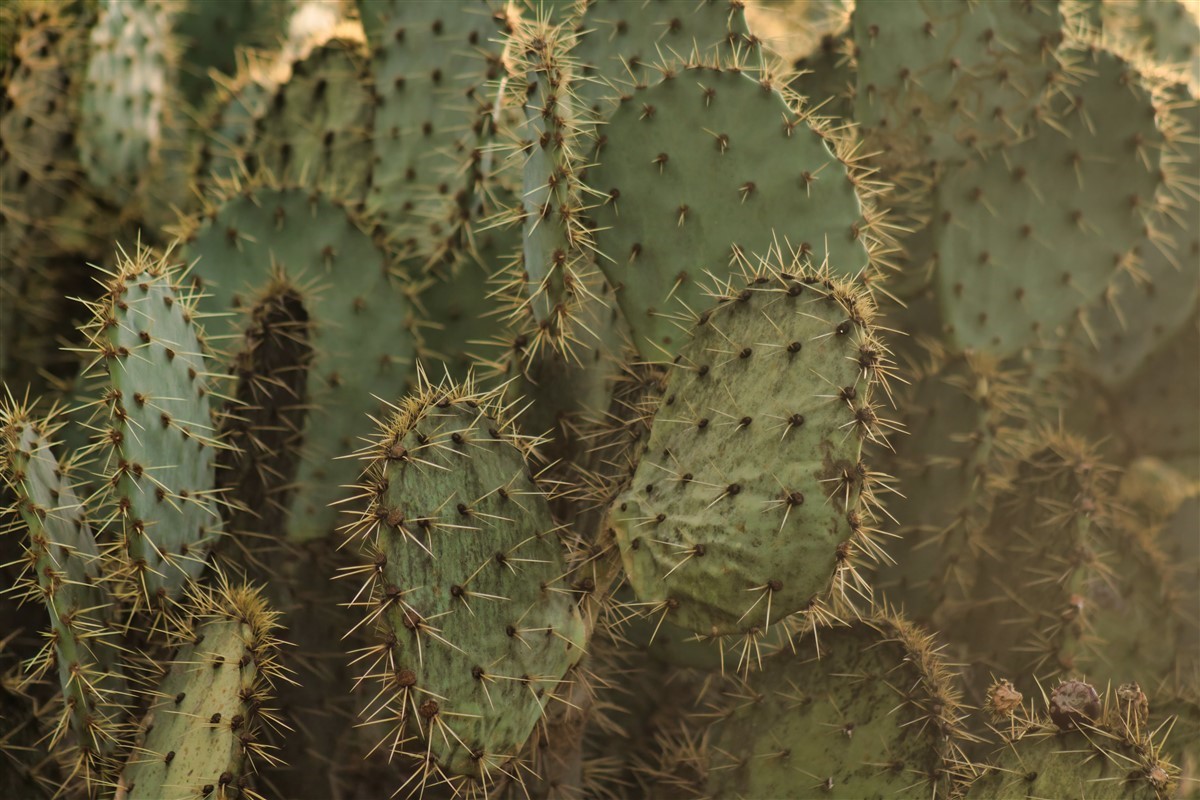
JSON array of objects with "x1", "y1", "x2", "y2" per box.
[{"x1": 962, "y1": 681, "x2": 1178, "y2": 800}]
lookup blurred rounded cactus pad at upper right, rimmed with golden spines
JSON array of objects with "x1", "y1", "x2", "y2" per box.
[{"x1": 935, "y1": 42, "x2": 1165, "y2": 357}]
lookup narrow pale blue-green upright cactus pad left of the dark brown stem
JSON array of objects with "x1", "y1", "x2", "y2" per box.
[{"x1": 85, "y1": 249, "x2": 221, "y2": 606}]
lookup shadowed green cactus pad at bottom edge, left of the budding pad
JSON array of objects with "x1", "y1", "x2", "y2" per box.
[{"x1": 652, "y1": 612, "x2": 961, "y2": 800}]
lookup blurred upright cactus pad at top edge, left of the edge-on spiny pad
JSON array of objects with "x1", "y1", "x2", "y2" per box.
[{"x1": 358, "y1": 0, "x2": 506, "y2": 263}]
